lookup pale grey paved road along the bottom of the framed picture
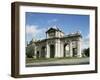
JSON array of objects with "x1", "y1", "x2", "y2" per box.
[{"x1": 26, "y1": 58, "x2": 89, "y2": 67}]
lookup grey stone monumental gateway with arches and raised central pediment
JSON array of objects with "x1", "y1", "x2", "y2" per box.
[{"x1": 27, "y1": 27, "x2": 82, "y2": 59}]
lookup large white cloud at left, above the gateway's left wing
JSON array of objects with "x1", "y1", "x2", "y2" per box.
[{"x1": 26, "y1": 25, "x2": 46, "y2": 39}]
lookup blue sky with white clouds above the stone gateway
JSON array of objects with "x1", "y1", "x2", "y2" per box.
[{"x1": 25, "y1": 12, "x2": 89, "y2": 47}]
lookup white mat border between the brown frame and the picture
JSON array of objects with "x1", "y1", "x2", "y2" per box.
[{"x1": 19, "y1": 5, "x2": 95, "y2": 74}]
